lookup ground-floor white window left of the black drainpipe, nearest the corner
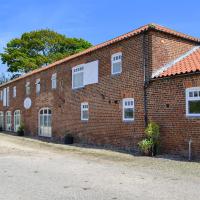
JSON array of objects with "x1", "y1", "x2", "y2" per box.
[{"x1": 123, "y1": 98, "x2": 134, "y2": 121}]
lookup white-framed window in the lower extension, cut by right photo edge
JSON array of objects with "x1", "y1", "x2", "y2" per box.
[{"x1": 186, "y1": 87, "x2": 200, "y2": 117}]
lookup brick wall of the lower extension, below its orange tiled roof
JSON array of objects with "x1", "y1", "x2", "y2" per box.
[{"x1": 148, "y1": 74, "x2": 200, "y2": 158}]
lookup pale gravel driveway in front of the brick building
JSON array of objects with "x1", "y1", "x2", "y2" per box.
[{"x1": 0, "y1": 134, "x2": 200, "y2": 200}]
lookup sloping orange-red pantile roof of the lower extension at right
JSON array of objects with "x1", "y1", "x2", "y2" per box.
[{"x1": 157, "y1": 48, "x2": 200, "y2": 77}]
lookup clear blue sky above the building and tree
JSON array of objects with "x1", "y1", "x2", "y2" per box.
[{"x1": 0, "y1": 0, "x2": 200, "y2": 73}]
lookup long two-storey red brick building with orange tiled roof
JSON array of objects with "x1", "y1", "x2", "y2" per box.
[{"x1": 0, "y1": 24, "x2": 200, "y2": 157}]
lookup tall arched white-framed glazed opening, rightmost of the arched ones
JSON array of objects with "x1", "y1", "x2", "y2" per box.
[{"x1": 38, "y1": 107, "x2": 52, "y2": 137}]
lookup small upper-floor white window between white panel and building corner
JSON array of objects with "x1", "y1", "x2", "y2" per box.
[{"x1": 111, "y1": 52, "x2": 122, "y2": 75}]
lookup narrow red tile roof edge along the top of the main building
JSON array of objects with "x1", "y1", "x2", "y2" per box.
[{"x1": 0, "y1": 23, "x2": 200, "y2": 87}]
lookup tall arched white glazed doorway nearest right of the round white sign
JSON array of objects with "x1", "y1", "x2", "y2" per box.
[{"x1": 39, "y1": 108, "x2": 52, "y2": 137}]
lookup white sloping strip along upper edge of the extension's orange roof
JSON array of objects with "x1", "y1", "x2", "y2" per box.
[{"x1": 152, "y1": 46, "x2": 200, "y2": 78}]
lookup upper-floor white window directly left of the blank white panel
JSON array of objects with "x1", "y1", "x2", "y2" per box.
[{"x1": 72, "y1": 66, "x2": 84, "y2": 89}]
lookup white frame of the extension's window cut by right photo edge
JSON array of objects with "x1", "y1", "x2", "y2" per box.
[{"x1": 185, "y1": 87, "x2": 200, "y2": 117}]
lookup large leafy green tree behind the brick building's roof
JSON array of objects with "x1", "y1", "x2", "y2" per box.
[{"x1": 0, "y1": 29, "x2": 92, "y2": 73}]
